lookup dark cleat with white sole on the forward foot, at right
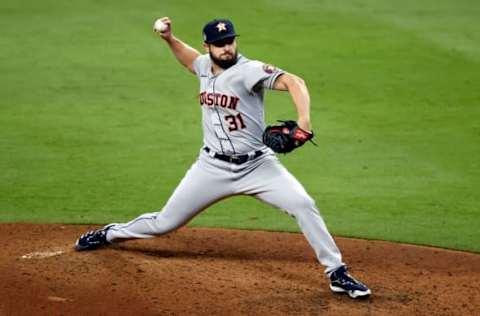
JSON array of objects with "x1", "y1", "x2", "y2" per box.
[{"x1": 330, "y1": 266, "x2": 372, "y2": 298}]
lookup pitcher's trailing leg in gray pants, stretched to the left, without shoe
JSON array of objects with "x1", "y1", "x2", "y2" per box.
[{"x1": 107, "y1": 160, "x2": 232, "y2": 241}]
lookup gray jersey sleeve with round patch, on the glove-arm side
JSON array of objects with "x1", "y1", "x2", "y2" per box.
[{"x1": 245, "y1": 61, "x2": 284, "y2": 91}]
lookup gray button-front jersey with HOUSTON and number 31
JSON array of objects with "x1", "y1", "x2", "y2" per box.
[{"x1": 193, "y1": 54, "x2": 283, "y2": 155}]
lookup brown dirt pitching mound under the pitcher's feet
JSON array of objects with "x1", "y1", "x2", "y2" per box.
[{"x1": 0, "y1": 224, "x2": 480, "y2": 316}]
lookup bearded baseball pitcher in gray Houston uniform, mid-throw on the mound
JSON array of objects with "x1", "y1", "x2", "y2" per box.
[{"x1": 75, "y1": 18, "x2": 371, "y2": 298}]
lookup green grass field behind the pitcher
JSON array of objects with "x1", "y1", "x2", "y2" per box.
[{"x1": 0, "y1": 0, "x2": 480, "y2": 252}]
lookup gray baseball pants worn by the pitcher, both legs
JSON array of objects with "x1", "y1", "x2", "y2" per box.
[{"x1": 107, "y1": 150, "x2": 343, "y2": 275}]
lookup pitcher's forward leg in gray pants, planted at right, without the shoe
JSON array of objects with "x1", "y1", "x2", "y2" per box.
[{"x1": 245, "y1": 158, "x2": 344, "y2": 274}]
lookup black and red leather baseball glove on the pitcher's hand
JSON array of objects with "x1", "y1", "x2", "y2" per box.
[{"x1": 263, "y1": 121, "x2": 315, "y2": 154}]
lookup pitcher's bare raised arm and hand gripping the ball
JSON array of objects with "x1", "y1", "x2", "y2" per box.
[{"x1": 154, "y1": 17, "x2": 200, "y2": 73}]
